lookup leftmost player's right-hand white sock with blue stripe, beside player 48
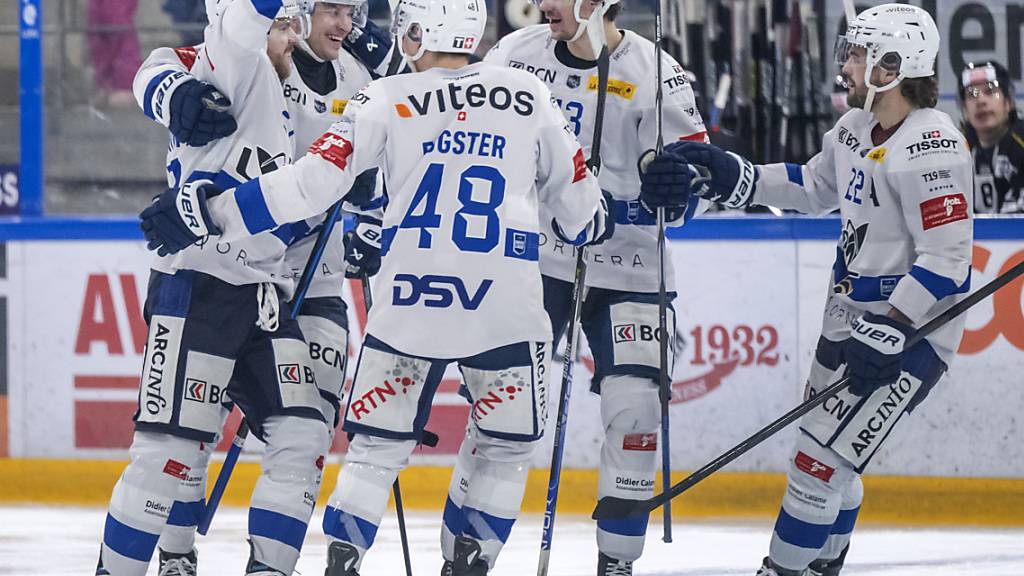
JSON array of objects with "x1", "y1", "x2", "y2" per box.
[{"x1": 249, "y1": 416, "x2": 329, "y2": 574}]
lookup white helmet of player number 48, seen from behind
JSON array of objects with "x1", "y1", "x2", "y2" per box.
[{"x1": 391, "y1": 0, "x2": 487, "y2": 61}]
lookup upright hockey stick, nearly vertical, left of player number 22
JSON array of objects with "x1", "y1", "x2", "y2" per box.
[{"x1": 655, "y1": 0, "x2": 672, "y2": 542}]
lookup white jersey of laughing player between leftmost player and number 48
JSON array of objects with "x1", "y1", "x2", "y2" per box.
[{"x1": 283, "y1": 47, "x2": 373, "y2": 298}]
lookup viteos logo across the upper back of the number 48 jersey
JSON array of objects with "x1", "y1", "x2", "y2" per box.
[{"x1": 391, "y1": 82, "x2": 534, "y2": 118}]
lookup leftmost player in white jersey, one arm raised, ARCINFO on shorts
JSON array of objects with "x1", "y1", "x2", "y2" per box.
[{"x1": 97, "y1": 0, "x2": 328, "y2": 575}]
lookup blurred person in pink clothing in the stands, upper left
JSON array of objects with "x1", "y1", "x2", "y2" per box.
[{"x1": 89, "y1": 0, "x2": 142, "y2": 107}]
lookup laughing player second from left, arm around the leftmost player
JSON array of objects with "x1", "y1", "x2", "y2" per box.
[{"x1": 128, "y1": 0, "x2": 386, "y2": 576}]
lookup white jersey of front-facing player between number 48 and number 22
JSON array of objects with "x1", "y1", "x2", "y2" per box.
[{"x1": 484, "y1": 25, "x2": 707, "y2": 292}]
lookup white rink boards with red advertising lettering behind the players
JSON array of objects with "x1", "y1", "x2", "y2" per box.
[{"x1": 0, "y1": 222, "x2": 1024, "y2": 478}]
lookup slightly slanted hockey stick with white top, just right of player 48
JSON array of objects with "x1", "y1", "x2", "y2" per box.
[{"x1": 537, "y1": 8, "x2": 610, "y2": 576}]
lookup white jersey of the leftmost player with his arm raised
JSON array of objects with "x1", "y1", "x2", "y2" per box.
[{"x1": 134, "y1": 0, "x2": 295, "y2": 295}]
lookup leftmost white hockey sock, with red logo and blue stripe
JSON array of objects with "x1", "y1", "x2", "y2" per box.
[{"x1": 100, "y1": 431, "x2": 204, "y2": 576}]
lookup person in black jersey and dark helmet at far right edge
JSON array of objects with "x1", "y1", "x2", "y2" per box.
[{"x1": 959, "y1": 61, "x2": 1024, "y2": 214}]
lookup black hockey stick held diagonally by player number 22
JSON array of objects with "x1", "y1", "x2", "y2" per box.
[{"x1": 593, "y1": 261, "x2": 1024, "y2": 520}]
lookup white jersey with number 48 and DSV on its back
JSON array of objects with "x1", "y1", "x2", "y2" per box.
[{"x1": 208, "y1": 63, "x2": 600, "y2": 359}]
